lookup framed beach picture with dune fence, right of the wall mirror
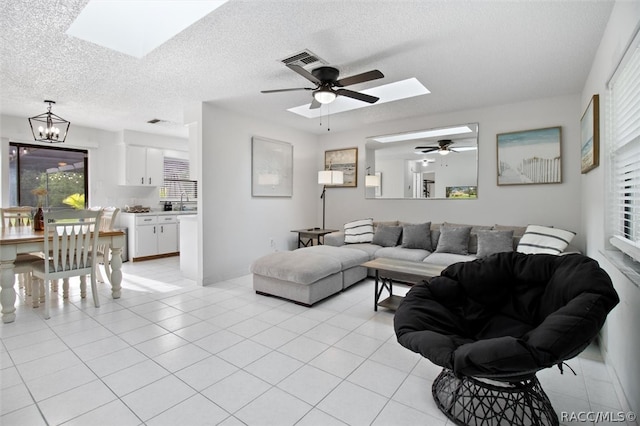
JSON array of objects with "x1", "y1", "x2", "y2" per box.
[{"x1": 497, "y1": 127, "x2": 562, "y2": 185}]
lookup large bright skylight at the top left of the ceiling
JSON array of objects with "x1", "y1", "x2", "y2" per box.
[{"x1": 67, "y1": 0, "x2": 226, "y2": 58}]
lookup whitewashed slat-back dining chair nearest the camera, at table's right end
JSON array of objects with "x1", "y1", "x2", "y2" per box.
[{"x1": 32, "y1": 210, "x2": 102, "y2": 319}]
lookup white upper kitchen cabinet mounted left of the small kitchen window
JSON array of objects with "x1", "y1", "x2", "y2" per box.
[{"x1": 121, "y1": 145, "x2": 164, "y2": 186}]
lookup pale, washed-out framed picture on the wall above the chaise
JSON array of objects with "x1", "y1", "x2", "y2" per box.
[{"x1": 251, "y1": 136, "x2": 293, "y2": 197}]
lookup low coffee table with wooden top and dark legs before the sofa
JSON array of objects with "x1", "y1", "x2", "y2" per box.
[{"x1": 362, "y1": 258, "x2": 446, "y2": 311}]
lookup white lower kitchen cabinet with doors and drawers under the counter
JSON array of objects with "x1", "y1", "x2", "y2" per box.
[{"x1": 120, "y1": 213, "x2": 179, "y2": 261}]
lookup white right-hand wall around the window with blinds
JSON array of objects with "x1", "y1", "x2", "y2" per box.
[{"x1": 580, "y1": 1, "x2": 640, "y2": 413}]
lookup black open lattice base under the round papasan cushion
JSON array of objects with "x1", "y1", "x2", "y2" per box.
[{"x1": 432, "y1": 368, "x2": 559, "y2": 426}]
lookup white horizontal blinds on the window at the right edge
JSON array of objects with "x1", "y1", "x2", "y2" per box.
[{"x1": 609, "y1": 30, "x2": 640, "y2": 260}]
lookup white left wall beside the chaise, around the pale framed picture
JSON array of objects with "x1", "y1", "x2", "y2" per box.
[{"x1": 201, "y1": 104, "x2": 322, "y2": 284}]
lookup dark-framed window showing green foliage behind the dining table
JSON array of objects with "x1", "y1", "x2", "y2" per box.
[{"x1": 9, "y1": 142, "x2": 88, "y2": 209}]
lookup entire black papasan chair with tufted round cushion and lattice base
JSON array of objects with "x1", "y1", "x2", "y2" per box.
[{"x1": 394, "y1": 252, "x2": 619, "y2": 425}]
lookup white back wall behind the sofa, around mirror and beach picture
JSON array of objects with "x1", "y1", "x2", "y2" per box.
[{"x1": 316, "y1": 95, "x2": 585, "y2": 248}]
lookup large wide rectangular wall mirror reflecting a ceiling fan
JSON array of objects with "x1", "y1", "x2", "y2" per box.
[{"x1": 365, "y1": 123, "x2": 478, "y2": 200}]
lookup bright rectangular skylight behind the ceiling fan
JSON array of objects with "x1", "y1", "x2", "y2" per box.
[{"x1": 287, "y1": 78, "x2": 431, "y2": 118}]
